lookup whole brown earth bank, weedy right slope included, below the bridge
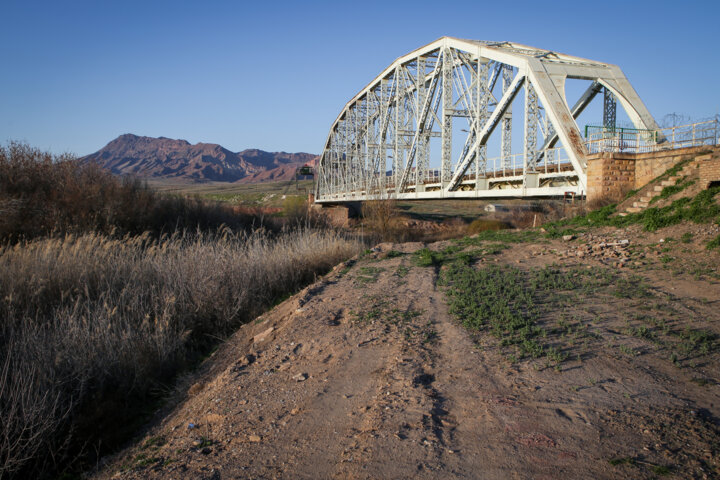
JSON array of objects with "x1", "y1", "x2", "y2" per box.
[{"x1": 96, "y1": 227, "x2": 720, "y2": 479}]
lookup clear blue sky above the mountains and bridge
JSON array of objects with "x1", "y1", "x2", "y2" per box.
[{"x1": 0, "y1": 0, "x2": 720, "y2": 155}]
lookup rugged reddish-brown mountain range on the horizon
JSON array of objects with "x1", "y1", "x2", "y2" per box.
[{"x1": 80, "y1": 133, "x2": 318, "y2": 183}]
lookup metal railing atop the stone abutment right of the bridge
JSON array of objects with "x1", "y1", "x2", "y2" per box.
[{"x1": 586, "y1": 118, "x2": 720, "y2": 154}]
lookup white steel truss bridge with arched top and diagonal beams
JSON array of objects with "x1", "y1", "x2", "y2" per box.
[{"x1": 315, "y1": 37, "x2": 664, "y2": 203}]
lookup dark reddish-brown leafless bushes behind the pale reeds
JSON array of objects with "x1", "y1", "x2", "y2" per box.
[{"x1": 0, "y1": 142, "x2": 273, "y2": 241}]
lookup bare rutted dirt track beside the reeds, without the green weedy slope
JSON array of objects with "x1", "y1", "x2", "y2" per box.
[{"x1": 97, "y1": 231, "x2": 720, "y2": 479}]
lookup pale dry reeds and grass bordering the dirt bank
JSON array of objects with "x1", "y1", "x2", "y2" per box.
[{"x1": 0, "y1": 229, "x2": 360, "y2": 477}]
